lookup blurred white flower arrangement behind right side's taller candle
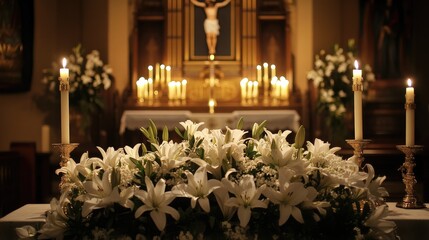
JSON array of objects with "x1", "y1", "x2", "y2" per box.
[{"x1": 307, "y1": 40, "x2": 375, "y2": 139}]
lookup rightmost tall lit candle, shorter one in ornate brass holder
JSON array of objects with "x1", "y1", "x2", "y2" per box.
[{"x1": 405, "y1": 79, "x2": 415, "y2": 146}]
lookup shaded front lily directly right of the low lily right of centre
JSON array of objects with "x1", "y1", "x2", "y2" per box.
[{"x1": 264, "y1": 168, "x2": 308, "y2": 226}]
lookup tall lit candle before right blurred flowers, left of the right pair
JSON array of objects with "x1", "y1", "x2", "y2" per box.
[{"x1": 353, "y1": 60, "x2": 363, "y2": 140}]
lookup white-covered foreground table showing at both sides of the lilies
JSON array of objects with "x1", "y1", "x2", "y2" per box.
[{"x1": 0, "y1": 202, "x2": 429, "y2": 240}]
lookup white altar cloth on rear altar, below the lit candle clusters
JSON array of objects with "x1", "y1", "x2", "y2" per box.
[{"x1": 119, "y1": 110, "x2": 300, "y2": 135}]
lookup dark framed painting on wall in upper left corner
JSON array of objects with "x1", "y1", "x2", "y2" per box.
[{"x1": 0, "y1": 0, "x2": 34, "y2": 93}]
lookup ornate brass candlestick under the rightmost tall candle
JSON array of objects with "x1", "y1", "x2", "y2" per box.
[{"x1": 396, "y1": 145, "x2": 426, "y2": 209}]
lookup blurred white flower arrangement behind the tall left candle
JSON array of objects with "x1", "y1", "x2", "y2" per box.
[{"x1": 36, "y1": 44, "x2": 113, "y2": 130}]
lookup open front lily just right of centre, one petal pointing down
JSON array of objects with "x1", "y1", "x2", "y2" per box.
[{"x1": 222, "y1": 175, "x2": 267, "y2": 227}]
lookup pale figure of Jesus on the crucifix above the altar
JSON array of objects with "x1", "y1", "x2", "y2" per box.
[{"x1": 191, "y1": 0, "x2": 231, "y2": 55}]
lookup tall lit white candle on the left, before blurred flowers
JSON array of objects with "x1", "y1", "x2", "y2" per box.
[{"x1": 60, "y1": 58, "x2": 70, "y2": 144}]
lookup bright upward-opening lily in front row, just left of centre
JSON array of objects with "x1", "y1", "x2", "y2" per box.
[{"x1": 172, "y1": 167, "x2": 220, "y2": 213}]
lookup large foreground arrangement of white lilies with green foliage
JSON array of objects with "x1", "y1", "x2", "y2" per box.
[{"x1": 20, "y1": 120, "x2": 395, "y2": 239}]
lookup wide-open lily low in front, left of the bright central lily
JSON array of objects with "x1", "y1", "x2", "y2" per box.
[{"x1": 134, "y1": 176, "x2": 180, "y2": 231}]
